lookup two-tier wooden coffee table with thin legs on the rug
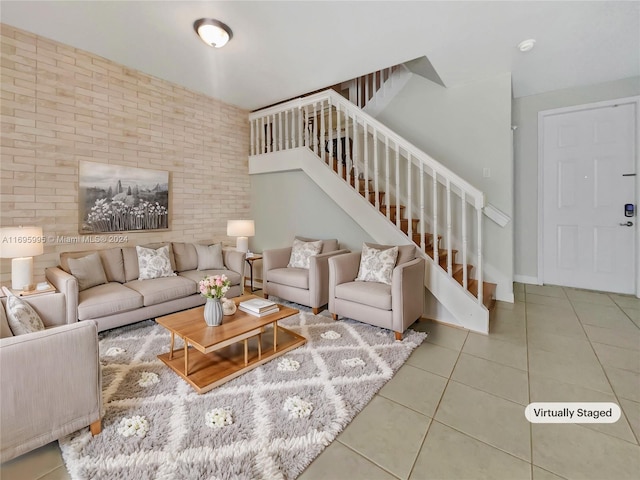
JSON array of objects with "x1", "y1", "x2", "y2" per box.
[{"x1": 156, "y1": 295, "x2": 307, "y2": 393}]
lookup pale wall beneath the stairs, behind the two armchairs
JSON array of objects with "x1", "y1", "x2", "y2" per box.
[{"x1": 249, "y1": 171, "x2": 373, "y2": 252}]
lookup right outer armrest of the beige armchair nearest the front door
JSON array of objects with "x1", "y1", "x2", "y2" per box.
[{"x1": 391, "y1": 257, "x2": 425, "y2": 332}]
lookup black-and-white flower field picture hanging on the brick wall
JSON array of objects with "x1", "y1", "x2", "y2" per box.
[{"x1": 78, "y1": 161, "x2": 169, "y2": 233}]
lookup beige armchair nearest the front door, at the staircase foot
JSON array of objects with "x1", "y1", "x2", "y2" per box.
[{"x1": 329, "y1": 244, "x2": 425, "y2": 340}]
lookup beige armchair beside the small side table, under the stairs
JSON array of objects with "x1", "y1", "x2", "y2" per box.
[{"x1": 262, "y1": 237, "x2": 349, "y2": 314}]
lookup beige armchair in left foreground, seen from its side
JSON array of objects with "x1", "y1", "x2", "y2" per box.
[{"x1": 0, "y1": 293, "x2": 102, "y2": 462}]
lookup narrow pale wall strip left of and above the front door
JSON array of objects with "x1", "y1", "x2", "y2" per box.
[{"x1": 513, "y1": 77, "x2": 640, "y2": 283}]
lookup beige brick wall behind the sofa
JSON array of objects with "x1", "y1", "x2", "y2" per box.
[{"x1": 0, "y1": 24, "x2": 250, "y2": 284}]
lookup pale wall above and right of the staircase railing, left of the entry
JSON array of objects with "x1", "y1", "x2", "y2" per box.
[{"x1": 376, "y1": 73, "x2": 514, "y2": 300}]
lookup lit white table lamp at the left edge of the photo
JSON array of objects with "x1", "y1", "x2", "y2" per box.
[{"x1": 0, "y1": 227, "x2": 44, "y2": 290}]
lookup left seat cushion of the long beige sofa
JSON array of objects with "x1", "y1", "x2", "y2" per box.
[{"x1": 78, "y1": 282, "x2": 143, "y2": 320}]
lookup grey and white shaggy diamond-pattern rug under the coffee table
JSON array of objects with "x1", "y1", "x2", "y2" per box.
[{"x1": 59, "y1": 311, "x2": 426, "y2": 480}]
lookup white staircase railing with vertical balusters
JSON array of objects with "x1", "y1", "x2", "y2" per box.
[{"x1": 249, "y1": 90, "x2": 485, "y2": 304}]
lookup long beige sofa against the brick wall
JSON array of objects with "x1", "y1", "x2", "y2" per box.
[{"x1": 46, "y1": 242, "x2": 245, "y2": 331}]
